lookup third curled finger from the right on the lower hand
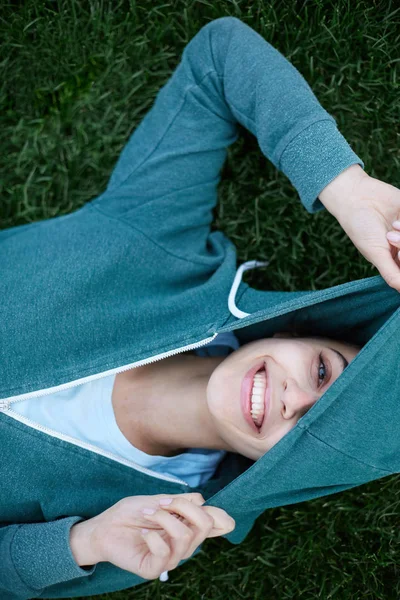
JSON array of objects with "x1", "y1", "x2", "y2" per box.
[{"x1": 145, "y1": 508, "x2": 193, "y2": 571}]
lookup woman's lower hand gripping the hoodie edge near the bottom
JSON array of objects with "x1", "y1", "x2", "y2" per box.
[{"x1": 70, "y1": 493, "x2": 235, "y2": 579}]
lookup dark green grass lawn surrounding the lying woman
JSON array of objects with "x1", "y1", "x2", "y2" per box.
[{"x1": 0, "y1": 0, "x2": 400, "y2": 600}]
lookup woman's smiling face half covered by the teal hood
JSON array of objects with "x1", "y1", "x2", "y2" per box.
[{"x1": 207, "y1": 334, "x2": 360, "y2": 460}]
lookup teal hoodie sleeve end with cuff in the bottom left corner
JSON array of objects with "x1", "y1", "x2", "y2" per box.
[{"x1": 0, "y1": 517, "x2": 96, "y2": 600}]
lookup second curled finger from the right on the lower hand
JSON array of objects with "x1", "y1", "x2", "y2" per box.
[{"x1": 156, "y1": 497, "x2": 214, "y2": 560}]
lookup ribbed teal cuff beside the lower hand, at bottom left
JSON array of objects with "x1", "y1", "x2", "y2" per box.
[{"x1": 10, "y1": 517, "x2": 96, "y2": 591}]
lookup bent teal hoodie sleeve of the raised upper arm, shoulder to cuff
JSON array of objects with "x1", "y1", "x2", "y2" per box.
[{"x1": 100, "y1": 17, "x2": 364, "y2": 244}]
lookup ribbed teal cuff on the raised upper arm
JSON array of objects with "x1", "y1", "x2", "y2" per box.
[{"x1": 278, "y1": 120, "x2": 364, "y2": 213}]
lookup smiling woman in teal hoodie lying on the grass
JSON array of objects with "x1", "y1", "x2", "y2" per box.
[{"x1": 0, "y1": 17, "x2": 400, "y2": 600}]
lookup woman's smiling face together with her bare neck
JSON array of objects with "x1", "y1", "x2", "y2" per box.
[{"x1": 112, "y1": 334, "x2": 359, "y2": 460}]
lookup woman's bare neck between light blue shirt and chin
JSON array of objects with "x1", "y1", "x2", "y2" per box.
[{"x1": 113, "y1": 353, "x2": 232, "y2": 456}]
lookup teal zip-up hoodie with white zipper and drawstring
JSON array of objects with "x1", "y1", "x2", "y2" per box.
[{"x1": 0, "y1": 17, "x2": 400, "y2": 600}]
